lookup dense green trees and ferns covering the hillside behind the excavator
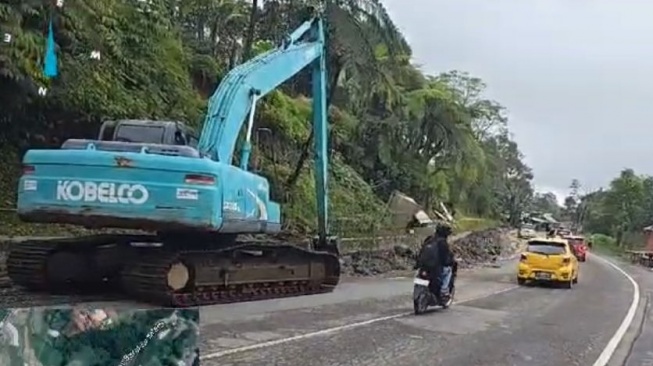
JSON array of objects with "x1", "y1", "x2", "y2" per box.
[{"x1": 0, "y1": 0, "x2": 532, "y2": 235}]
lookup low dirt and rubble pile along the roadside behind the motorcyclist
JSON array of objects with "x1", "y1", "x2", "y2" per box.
[{"x1": 341, "y1": 229, "x2": 519, "y2": 276}]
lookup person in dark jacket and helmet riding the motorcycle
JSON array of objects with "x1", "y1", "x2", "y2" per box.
[{"x1": 416, "y1": 224, "x2": 455, "y2": 301}]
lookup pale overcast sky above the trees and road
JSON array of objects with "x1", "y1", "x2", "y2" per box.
[{"x1": 382, "y1": 0, "x2": 653, "y2": 202}]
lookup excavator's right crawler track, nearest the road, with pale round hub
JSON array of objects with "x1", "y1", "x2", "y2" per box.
[{"x1": 121, "y1": 243, "x2": 340, "y2": 307}]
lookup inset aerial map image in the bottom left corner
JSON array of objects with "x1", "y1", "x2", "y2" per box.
[{"x1": 0, "y1": 307, "x2": 199, "y2": 366}]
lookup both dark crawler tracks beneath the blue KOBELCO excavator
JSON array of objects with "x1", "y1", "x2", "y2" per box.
[{"x1": 7, "y1": 235, "x2": 340, "y2": 307}]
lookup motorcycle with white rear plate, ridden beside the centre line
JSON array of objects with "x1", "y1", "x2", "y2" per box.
[{"x1": 413, "y1": 262, "x2": 458, "y2": 315}]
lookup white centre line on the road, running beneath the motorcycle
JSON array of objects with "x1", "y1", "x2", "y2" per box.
[{"x1": 200, "y1": 286, "x2": 521, "y2": 361}]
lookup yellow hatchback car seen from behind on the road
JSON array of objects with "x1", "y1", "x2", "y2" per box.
[{"x1": 517, "y1": 238, "x2": 578, "y2": 288}]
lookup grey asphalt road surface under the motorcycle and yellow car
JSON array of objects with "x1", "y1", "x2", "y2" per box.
[{"x1": 200, "y1": 254, "x2": 636, "y2": 366}]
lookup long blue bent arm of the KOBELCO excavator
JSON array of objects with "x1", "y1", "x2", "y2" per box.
[{"x1": 198, "y1": 17, "x2": 329, "y2": 243}]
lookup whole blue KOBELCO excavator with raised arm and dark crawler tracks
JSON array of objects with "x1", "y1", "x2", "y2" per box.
[{"x1": 7, "y1": 12, "x2": 340, "y2": 307}]
